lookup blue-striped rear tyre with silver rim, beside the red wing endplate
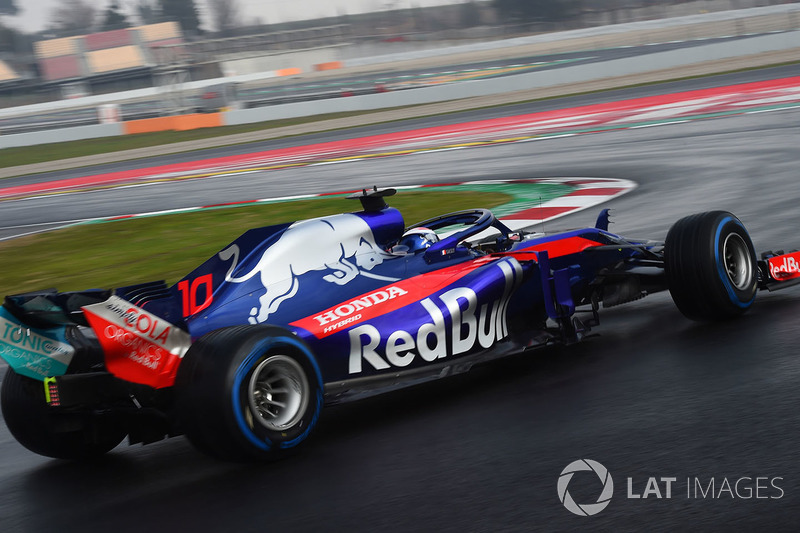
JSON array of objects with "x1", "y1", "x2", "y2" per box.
[{"x1": 175, "y1": 325, "x2": 322, "y2": 462}]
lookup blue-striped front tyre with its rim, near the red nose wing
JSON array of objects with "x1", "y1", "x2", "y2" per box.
[{"x1": 664, "y1": 211, "x2": 758, "y2": 321}]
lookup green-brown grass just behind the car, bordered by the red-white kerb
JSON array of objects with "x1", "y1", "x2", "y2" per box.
[{"x1": 0, "y1": 191, "x2": 510, "y2": 297}]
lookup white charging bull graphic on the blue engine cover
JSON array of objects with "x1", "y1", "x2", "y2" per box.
[{"x1": 219, "y1": 214, "x2": 397, "y2": 324}]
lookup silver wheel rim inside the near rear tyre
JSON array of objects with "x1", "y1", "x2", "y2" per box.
[{"x1": 247, "y1": 355, "x2": 310, "y2": 431}]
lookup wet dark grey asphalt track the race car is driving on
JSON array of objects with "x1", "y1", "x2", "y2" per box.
[{"x1": 0, "y1": 72, "x2": 800, "y2": 532}]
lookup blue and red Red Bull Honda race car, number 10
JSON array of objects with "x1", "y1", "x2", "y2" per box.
[{"x1": 0, "y1": 189, "x2": 800, "y2": 461}]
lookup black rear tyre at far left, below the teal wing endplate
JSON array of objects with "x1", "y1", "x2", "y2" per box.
[{"x1": 0, "y1": 368, "x2": 127, "y2": 460}]
